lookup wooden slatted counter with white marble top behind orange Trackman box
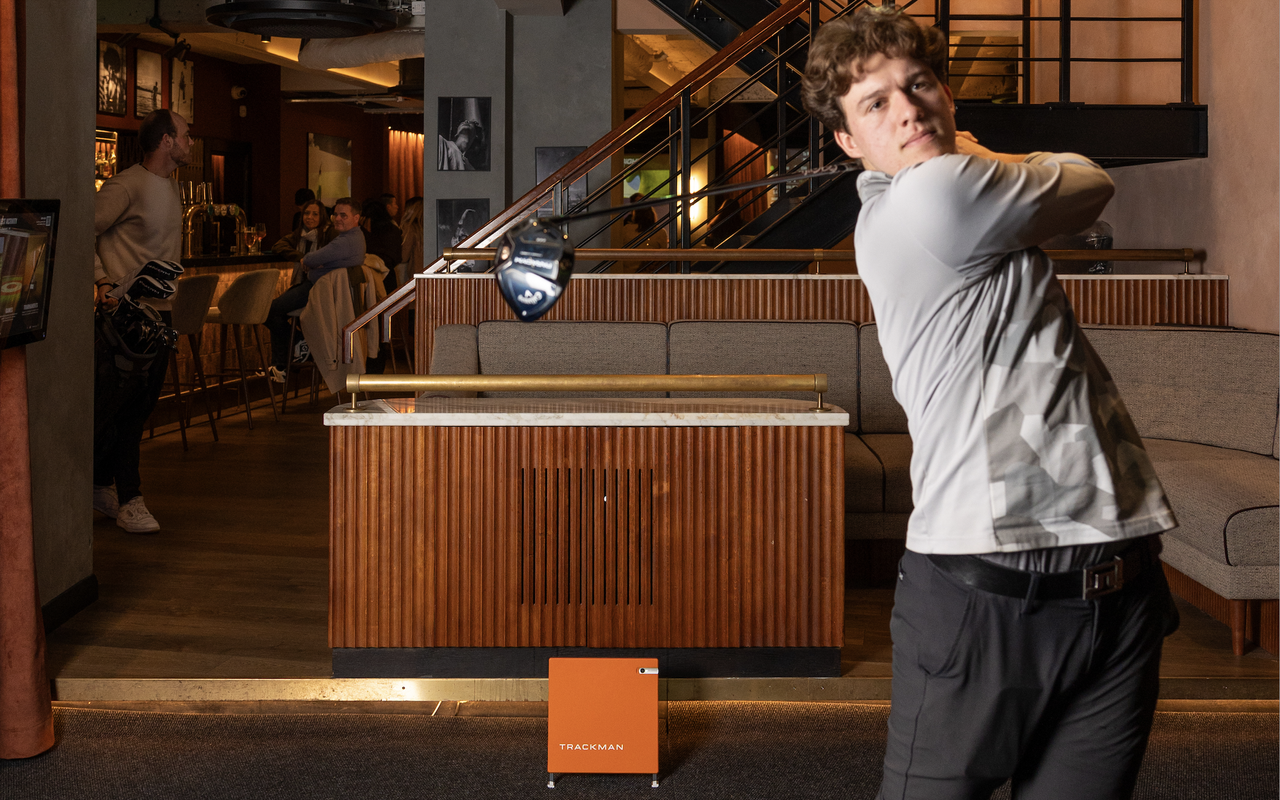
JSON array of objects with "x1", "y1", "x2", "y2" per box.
[{"x1": 325, "y1": 398, "x2": 849, "y2": 677}]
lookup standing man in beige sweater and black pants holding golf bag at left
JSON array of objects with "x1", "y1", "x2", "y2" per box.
[{"x1": 93, "y1": 109, "x2": 193, "y2": 534}]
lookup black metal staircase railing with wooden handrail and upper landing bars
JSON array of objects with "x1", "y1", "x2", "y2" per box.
[{"x1": 343, "y1": 0, "x2": 1194, "y2": 362}]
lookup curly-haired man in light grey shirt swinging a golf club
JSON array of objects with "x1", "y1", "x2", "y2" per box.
[{"x1": 804, "y1": 8, "x2": 1176, "y2": 800}]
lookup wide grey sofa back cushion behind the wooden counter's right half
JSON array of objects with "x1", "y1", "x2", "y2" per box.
[{"x1": 669, "y1": 321, "x2": 858, "y2": 417}]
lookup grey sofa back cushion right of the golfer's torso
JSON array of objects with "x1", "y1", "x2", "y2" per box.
[{"x1": 1085, "y1": 326, "x2": 1280, "y2": 456}]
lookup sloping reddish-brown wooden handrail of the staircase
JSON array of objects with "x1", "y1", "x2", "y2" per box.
[{"x1": 342, "y1": 0, "x2": 809, "y2": 364}]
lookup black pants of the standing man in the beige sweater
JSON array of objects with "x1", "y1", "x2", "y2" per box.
[{"x1": 93, "y1": 321, "x2": 169, "y2": 506}]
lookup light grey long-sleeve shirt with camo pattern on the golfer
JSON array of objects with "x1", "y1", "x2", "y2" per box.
[{"x1": 855, "y1": 154, "x2": 1176, "y2": 553}]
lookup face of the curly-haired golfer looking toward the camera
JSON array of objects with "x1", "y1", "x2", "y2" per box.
[{"x1": 836, "y1": 54, "x2": 956, "y2": 175}]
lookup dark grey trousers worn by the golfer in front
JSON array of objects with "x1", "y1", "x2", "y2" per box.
[{"x1": 879, "y1": 550, "x2": 1171, "y2": 800}]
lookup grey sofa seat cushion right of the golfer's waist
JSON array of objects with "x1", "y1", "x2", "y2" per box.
[{"x1": 1143, "y1": 439, "x2": 1280, "y2": 570}]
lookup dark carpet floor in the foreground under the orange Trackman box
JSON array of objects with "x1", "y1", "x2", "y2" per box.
[{"x1": 0, "y1": 703, "x2": 1280, "y2": 800}]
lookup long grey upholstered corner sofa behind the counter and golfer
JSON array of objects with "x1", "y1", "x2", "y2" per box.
[{"x1": 430, "y1": 321, "x2": 1280, "y2": 652}]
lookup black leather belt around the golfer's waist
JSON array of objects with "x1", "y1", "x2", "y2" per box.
[{"x1": 928, "y1": 538, "x2": 1155, "y2": 600}]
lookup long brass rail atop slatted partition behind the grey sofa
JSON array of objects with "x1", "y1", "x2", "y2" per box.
[{"x1": 444, "y1": 247, "x2": 1196, "y2": 261}]
